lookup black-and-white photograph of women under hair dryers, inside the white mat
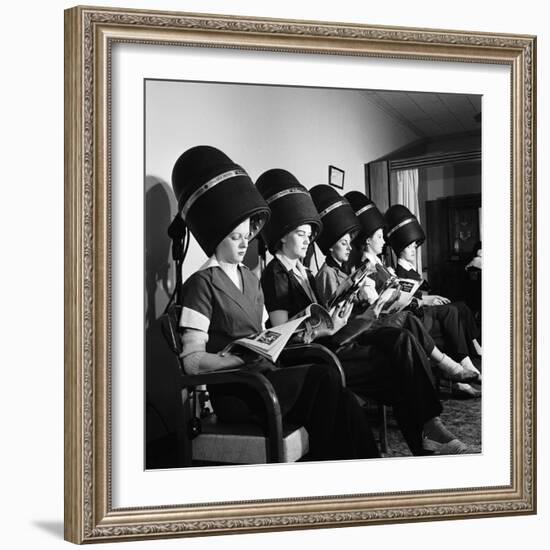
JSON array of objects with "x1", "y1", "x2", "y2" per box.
[{"x1": 143, "y1": 79, "x2": 485, "y2": 470}]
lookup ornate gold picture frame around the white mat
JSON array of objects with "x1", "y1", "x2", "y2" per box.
[{"x1": 64, "y1": 7, "x2": 536, "y2": 543}]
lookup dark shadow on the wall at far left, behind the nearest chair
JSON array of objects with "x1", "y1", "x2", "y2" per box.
[{"x1": 144, "y1": 176, "x2": 182, "y2": 468}]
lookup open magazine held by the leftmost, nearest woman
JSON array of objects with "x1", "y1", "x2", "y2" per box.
[{"x1": 222, "y1": 304, "x2": 333, "y2": 362}]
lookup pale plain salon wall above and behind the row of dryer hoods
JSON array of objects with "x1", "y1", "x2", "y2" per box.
[{"x1": 146, "y1": 81, "x2": 415, "y2": 312}]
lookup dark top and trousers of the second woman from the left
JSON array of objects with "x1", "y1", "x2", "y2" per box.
[{"x1": 262, "y1": 257, "x2": 442, "y2": 455}]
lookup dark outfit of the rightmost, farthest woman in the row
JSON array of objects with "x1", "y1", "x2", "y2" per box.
[{"x1": 395, "y1": 263, "x2": 479, "y2": 361}]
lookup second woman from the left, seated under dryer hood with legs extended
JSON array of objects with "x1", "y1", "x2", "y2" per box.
[{"x1": 256, "y1": 174, "x2": 474, "y2": 455}]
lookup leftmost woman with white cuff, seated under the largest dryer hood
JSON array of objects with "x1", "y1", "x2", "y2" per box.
[{"x1": 172, "y1": 146, "x2": 379, "y2": 460}]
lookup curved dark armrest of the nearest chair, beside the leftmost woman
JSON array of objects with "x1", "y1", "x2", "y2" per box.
[{"x1": 181, "y1": 365, "x2": 284, "y2": 462}]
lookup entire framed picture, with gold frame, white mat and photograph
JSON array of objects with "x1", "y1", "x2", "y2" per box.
[{"x1": 59, "y1": 6, "x2": 537, "y2": 546}]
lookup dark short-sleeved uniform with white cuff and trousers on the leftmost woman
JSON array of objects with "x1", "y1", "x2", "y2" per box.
[{"x1": 180, "y1": 263, "x2": 379, "y2": 460}]
